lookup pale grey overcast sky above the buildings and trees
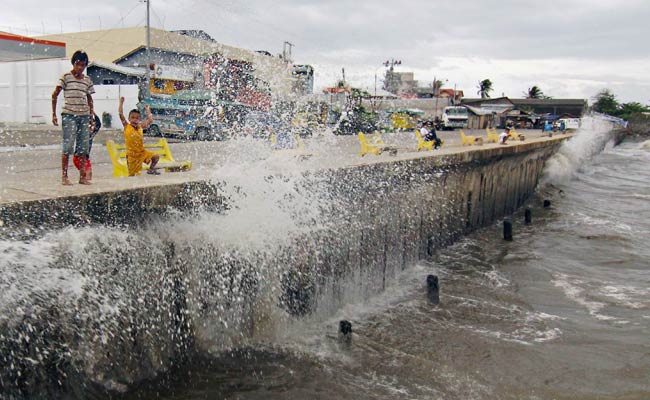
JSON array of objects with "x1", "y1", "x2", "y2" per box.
[{"x1": 0, "y1": 0, "x2": 650, "y2": 105}]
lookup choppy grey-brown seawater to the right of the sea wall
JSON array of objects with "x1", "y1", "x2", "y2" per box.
[{"x1": 125, "y1": 136, "x2": 650, "y2": 400}]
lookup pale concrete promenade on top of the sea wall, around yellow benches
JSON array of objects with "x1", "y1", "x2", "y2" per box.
[{"x1": 0, "y1": 127, "x2": 568, "y2": 205}]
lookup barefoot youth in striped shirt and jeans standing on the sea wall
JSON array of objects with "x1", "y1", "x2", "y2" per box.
[{"x1": 52, "y1": 50, "x2": 95, "y2": 186}]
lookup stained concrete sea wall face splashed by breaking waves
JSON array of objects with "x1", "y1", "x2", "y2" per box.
[{"x1": 0, "y1": 139, "x2": 562, "y2": 398}]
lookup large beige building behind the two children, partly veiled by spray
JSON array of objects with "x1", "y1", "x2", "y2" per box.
[{"x1": 44, "y1": 27, "x2": 296, "y2": 103}]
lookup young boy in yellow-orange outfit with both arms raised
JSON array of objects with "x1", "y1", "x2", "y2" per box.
[{"x1": 117, "y1": 97, "x2": 160, "y2": 176}]
